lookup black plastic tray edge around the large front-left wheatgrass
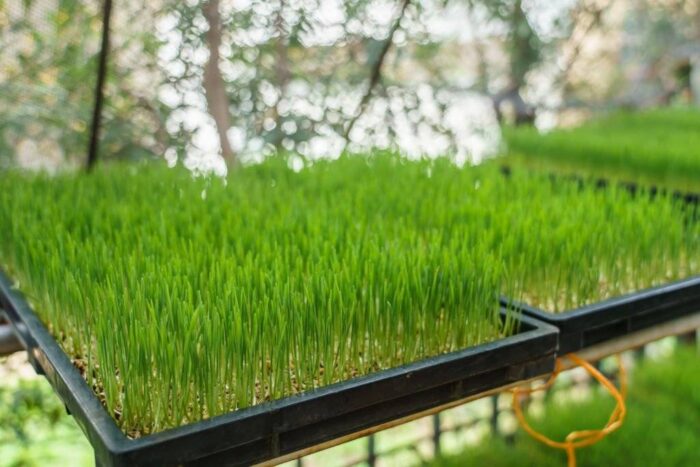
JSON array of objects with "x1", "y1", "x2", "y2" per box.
[{"x1": 0, "y1": 271, "x2": 557, "y2": 466}]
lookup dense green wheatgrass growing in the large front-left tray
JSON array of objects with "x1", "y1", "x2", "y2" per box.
[{"x1": 0, "y1": 159, "x2": 512, "y2": 435}]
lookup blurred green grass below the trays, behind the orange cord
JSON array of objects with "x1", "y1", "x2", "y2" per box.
[{"x1": 432, "y1": 349, "x2": 700, "y2": 467}]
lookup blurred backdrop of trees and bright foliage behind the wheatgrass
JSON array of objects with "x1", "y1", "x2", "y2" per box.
[{"x1": 0, "y1": 0, "x2": 700, "y2": 170}]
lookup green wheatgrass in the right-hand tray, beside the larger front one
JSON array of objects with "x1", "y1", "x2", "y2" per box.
[{"x1": 503, "y1": 172, "x2": 700, "y2": 312}]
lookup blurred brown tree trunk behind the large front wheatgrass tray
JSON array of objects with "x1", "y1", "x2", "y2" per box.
[{"x1": 203, "y1": 0, "x2": 237, "y2": 167}]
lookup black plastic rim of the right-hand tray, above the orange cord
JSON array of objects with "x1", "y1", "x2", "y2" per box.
[{"x1": 501, "y1": 276, "x2": 700, "y2": 355}]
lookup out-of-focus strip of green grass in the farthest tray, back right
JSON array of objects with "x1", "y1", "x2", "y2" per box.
[{"x1": 503, "y1": 107, "x2": 700, "y2": 193}]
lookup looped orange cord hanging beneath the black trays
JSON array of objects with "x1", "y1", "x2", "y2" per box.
[{"x1": 512, "y1": 354, "x2": 627, "y2": 467}]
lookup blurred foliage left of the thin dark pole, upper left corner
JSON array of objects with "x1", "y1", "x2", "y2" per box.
[{"x1": 0, "y1": 0, "x2": 102, "y2": 170}]
